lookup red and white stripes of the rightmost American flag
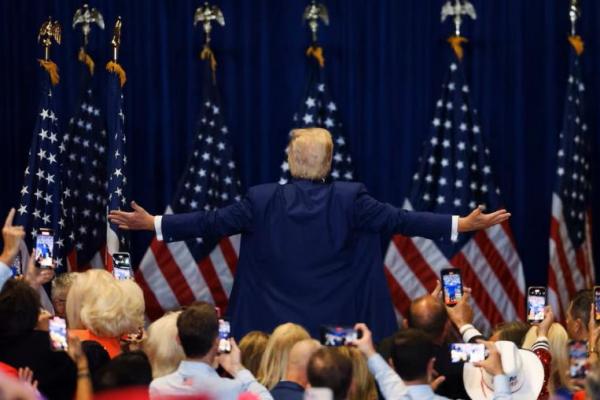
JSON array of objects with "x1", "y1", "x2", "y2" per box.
[{"x1": 548, "y1": 193, "x2": 596, "y2": 320}]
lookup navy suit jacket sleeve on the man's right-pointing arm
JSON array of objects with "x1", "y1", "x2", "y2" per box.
[{"x1": 354, "y1": 186, "x2": 452, "y2": 241}]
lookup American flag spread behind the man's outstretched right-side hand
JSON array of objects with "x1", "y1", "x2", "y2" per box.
[{"x1": 385, "y1": 47, "x2": 525, "y2": 330}]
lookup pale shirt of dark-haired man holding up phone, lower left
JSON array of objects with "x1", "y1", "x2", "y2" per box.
[{"x1": 150, "y1": 360, "x2": 273, "y2": 400}]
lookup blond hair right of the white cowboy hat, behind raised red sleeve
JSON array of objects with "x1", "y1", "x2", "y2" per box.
[{"x1": 523, "y1": 322, "x2": 572, "y2": 395}]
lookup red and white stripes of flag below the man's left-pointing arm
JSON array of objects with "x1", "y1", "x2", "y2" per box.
[{"x1": 135, "y1": 208, "x2": 240, "y2": 320}]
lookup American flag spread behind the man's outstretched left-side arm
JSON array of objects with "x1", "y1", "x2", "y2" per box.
[{"x1": 135, "y1": 54, "x2": 241, "y2": 319}]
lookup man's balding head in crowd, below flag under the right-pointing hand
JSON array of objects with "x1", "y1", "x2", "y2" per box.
[{"x1": 406, "y1": 295, "x2": 448, "y2": 340}]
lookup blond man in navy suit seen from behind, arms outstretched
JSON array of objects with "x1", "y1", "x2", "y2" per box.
[{"x1": 109, "y1": 128, "x2": 510, "y2": 339}]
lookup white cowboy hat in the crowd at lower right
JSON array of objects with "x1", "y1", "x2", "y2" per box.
[{"x1": 463, "y1": 341, "x2": 544, "y2": 400}]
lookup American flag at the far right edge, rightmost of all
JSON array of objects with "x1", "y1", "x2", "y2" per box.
[{"x1": 548, "y1": 38, "x2": 595, "y2": 319}]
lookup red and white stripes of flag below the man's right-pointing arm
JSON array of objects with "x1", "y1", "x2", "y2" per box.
[{"x1": 385, "y1": 201, "x2": 525, "y2": 331}]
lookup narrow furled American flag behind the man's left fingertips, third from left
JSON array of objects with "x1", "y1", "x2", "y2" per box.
[{"x1": 105, "y1": 61, "x2": 129, "y2": 267}]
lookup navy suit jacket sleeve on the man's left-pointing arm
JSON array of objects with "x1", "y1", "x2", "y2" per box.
[{"x1": 161, "y1": 197, "x2": 252, "y2": 242}]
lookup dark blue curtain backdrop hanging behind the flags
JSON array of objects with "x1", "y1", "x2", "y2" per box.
[{"x1": 0, "y1": 0, "x2": 600, "y2": 285}]
